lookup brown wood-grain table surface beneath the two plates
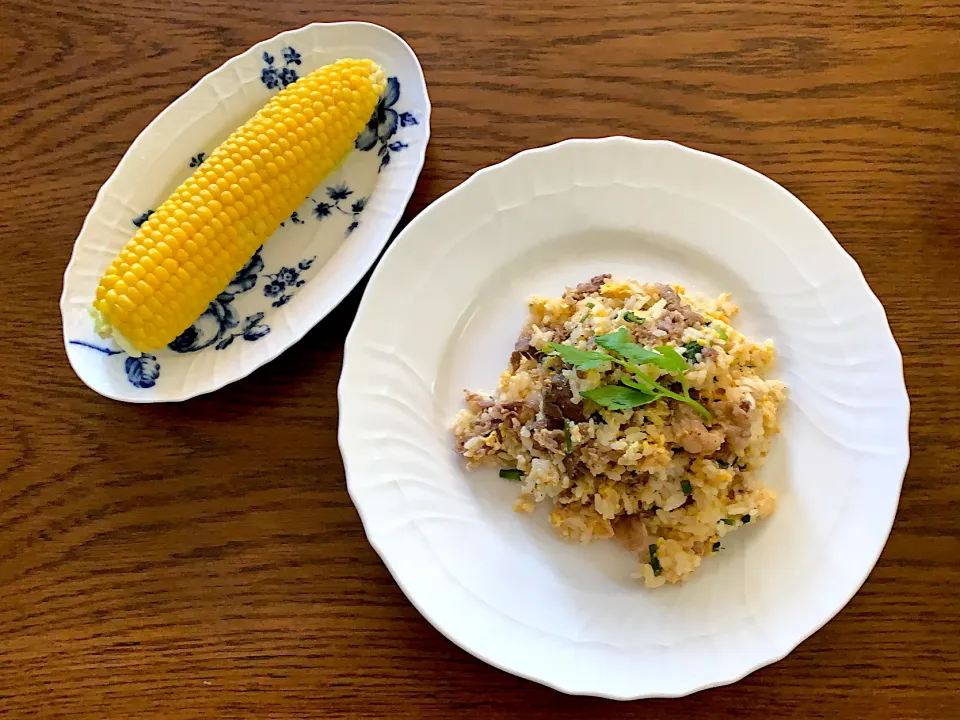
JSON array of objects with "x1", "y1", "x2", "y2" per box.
[{"x1": 0, "y1": 0, "x2": 960, "y2": 720}]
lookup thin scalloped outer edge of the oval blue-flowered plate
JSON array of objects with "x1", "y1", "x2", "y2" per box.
[{"x1": 59, "y1": 20, "x2": 432, "y2": 404}]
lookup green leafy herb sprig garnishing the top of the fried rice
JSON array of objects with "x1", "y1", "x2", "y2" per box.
[{"x1": 548, "y1": 327, "x2": 711, "y2": 420}]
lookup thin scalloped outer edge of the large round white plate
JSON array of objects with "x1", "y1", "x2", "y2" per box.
[{"x1": 337, "y1": 135, "x2": 910, "y2": 701}]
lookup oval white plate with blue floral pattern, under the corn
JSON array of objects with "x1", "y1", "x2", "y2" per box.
[{"x1": 60, "y1": 22, "x2": 430, "y2": 402}]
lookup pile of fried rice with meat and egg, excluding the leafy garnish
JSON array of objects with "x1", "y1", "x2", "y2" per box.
[{"x1": 453, "y1": 275, "x2": 786, "y2": 587}]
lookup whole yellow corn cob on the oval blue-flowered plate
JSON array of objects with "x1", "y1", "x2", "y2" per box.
[{"x1": 92, "y1": 59, "x2": 386, "y2": 354}]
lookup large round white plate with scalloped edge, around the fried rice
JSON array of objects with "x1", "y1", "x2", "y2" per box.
[{"x1": 340, "y1": 138, "x2": 909, "y2": 699}]
